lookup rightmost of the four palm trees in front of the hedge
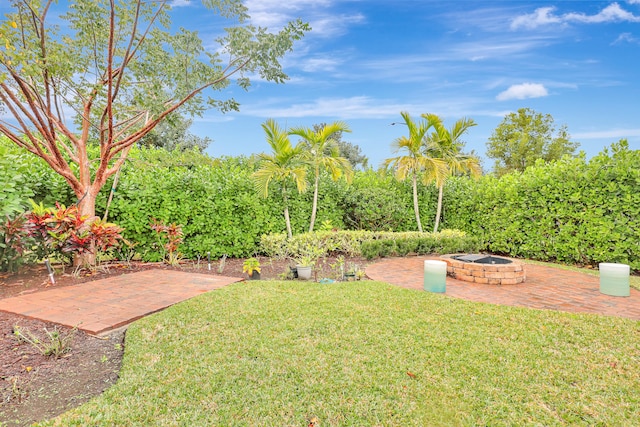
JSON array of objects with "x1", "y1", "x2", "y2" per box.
[{"x1": 422, "y1": 114, "x2": 482, "y2": 233}]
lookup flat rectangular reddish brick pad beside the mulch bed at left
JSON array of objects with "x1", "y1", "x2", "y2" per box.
[{"x1": 0, "y1": 269, "x2": 242, "y2": 335}]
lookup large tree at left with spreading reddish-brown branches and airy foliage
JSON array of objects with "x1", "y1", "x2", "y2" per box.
[{"x1": 0, "y1": 0, "x2": 309, "y2": 264}]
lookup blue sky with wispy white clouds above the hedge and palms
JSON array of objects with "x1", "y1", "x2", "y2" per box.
[{"x1": 168, "y1": 0, "x2": 640, "y2": 169}]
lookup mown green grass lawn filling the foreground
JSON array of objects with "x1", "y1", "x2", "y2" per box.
[{"x1": 46, "y1": 281, "x2": 640, "y2": 427}]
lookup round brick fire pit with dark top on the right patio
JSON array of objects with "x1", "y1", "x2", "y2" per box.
[{"x1": 440, "y1": 254, "x2": 526, "y2": 285}]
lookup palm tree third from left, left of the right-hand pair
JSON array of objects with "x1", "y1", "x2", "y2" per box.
[{"x1": 384, "y1": 111, "x2": 447, "y2": 233}]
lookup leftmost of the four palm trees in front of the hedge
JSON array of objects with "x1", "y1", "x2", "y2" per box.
[{"x1": 253, "y1": 119, "x2": 307, "y2": 238}]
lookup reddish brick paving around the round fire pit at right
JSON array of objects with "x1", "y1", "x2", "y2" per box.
[{"x1": 366, "y1": 257, "x2": 640, "y2": 320}]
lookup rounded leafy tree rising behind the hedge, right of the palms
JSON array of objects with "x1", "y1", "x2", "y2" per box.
[{"x1": 487, "y1": 108, "x2": 579, "y2": 176}]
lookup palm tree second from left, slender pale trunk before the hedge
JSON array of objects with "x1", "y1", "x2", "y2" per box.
[{"x1": 289, "y1": 121, "x2": 353, "y2": 232}]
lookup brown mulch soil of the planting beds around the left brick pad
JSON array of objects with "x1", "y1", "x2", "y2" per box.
[{"x1": 0, "y1": 258, "x2": 367, "y2": 426}]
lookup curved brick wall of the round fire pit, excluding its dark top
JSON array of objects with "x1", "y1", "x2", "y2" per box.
[{"x1": 440, "y1": 254, "x2": 526, "y2": 285}]
